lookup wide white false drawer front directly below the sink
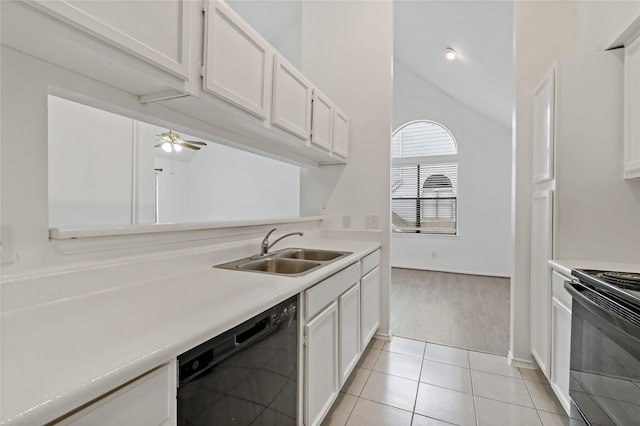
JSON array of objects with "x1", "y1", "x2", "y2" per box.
[{"x1": 304, "y1": 262, "x2": 360, "y2": 319}]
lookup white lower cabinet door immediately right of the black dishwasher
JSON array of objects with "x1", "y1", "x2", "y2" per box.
[{"x1": 304, "y1": 302, "x2": 340, "y2": 426}]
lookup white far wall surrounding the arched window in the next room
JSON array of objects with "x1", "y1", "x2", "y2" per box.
[{"x1": 391, "y1": 61, "x2": 511, "y2": 276}]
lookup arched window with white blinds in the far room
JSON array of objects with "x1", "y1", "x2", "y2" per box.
[{"x1": 391, "y1": 120, "x2": 458, "y2": 235}]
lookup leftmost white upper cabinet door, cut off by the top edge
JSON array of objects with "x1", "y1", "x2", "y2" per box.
[{"x1": 28, "y1": 0, "x2": 190, "y2": 80}]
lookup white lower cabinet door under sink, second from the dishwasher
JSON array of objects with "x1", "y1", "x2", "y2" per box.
[{"x1": 338, "y1": 283, "x2": 360, "y2": 386}]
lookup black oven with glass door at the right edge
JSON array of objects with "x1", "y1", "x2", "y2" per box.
[{"x1": 565, "y1": 270, "x2": 640, "y2": 426}]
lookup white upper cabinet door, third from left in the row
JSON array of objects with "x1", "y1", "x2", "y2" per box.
[{"x1": 273, "y1": 55, "x2": 311, "y2": 141}]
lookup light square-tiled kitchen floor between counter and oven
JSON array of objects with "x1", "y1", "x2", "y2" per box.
[{"x1": 323, "y1": 337, "x2": 570, "y2": 426}]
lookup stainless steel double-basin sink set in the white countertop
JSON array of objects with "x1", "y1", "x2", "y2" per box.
[{"x1": 215, "y1": 248, "x2": 353, "y2": 277}]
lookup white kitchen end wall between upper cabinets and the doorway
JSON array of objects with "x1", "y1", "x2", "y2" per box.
[{"x1": 301, "y1": 1, "x2": 393, "y2": 333}]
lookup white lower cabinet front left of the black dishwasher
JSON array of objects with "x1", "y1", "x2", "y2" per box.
[{"x1": 56, "y1": 361, "x2": 176, "y2": 426}]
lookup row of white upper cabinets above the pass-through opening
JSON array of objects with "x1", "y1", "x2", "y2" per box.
[{"x1": 8, "y1": 0, "x2": 349, "y2": 167}]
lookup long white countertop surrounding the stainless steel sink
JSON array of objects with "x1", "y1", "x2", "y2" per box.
[{"x1": 1, "y1": 239, "x2": 380, "y2": 425}]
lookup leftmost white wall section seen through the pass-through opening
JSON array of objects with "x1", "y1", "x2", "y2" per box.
[{"x1": 48, "y1": 96, "x2": 133, "y2": 227}]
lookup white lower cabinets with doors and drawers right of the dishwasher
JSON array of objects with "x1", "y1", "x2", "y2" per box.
[{"x1": 302, "y1": 250, "x2": 380, "y2": 426}]
